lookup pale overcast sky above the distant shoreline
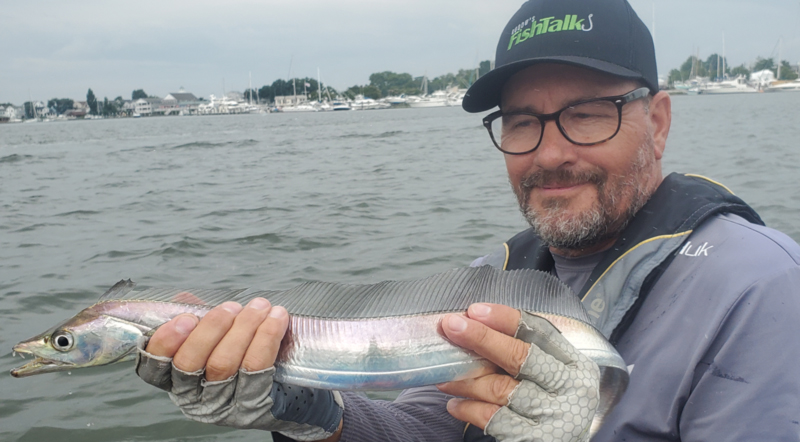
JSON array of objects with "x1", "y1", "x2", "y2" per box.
[{"x1": 0, "y1": 0, "x2": 800, "y2": 105}]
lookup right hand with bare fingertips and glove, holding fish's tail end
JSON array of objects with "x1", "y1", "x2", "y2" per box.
[{"x1": 439, "y1": 304, "x2": 600, "y2": 441}]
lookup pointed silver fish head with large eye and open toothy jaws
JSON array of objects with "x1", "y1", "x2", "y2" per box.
[{"x1": 11, "y1": 307, "x2": 147, "y2": 378}]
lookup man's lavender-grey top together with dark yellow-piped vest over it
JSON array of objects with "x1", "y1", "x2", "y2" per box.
[{"x1": 334, "y1": 174, "x2": 800, "y2": 442}]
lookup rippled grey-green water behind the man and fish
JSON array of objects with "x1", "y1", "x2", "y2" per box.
[{"x1": 0, "y1": 93, "x2": 800, "y2": 441}]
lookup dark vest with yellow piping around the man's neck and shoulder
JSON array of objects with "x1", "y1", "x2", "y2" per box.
[{"x1": 496, "y1": 173, "x2": 764, "y2": 343}]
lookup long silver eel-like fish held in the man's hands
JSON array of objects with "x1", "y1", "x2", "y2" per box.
[{"x1": 11, "y1": 267, "x2": 628, "y2": 434}]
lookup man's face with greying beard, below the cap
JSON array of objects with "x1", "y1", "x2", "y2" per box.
[{"x1": 501, "y1": 64, "x2": 663, "y2": 256}]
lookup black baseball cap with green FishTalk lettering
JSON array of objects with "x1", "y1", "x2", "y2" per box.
[{"x1": 462, "y1": 0, "x2": 658, "y2": 112}]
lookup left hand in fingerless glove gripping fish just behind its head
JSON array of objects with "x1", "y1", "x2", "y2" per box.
[{"x1": 136, "y1": 298, "x2": 344, "y2": 441}]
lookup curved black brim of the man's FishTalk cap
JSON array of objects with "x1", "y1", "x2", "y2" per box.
[{"x1": 461, "y1": 56, "x2": 658, "y2": 113}]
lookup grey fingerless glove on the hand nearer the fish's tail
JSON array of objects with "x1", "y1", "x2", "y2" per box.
[{"x1": 485, "y1": 312, "x2": 600, "y2": 442}]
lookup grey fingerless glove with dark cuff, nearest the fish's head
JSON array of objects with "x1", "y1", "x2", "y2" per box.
[{"x1": 136, "y1": 342, "x2": 344, "y2": 441}]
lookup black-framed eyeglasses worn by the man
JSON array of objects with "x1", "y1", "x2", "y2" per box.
[{"x1": 483, "y1": 87, "x2": 650, "y2": 155}]
